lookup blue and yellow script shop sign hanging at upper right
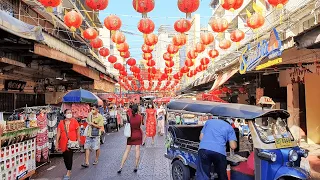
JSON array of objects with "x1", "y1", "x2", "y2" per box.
[{"x1": 239, "y1": 28, "x2": 282, "y2": 74}]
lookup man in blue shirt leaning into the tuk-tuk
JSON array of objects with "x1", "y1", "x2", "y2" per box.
[{"x1": 196, "y1": 119, "x2": 237, "y2": 180}]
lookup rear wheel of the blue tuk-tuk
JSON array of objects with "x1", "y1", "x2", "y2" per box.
[{"x1": 171, "y1": 160, "x2": 190, "y2": 180}]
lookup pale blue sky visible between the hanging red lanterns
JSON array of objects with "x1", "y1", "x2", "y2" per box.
[{"x1": 99, "y1": 0, "x2": 212, "y2": 60}]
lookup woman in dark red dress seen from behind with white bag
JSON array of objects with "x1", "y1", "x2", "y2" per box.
[{"x1": 118, "y1": 105, "x2": 142, "y2": 174}]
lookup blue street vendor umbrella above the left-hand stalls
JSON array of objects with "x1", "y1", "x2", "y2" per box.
[{"x1": 62, "y1": 89, "x2": 98, "y2": 104}]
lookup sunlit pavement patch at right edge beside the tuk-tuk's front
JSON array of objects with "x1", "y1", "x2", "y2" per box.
[{"x1": 300, "y1": 142, "x2": 320, "y2": 180}]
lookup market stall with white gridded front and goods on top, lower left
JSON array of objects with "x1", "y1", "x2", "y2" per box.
[{"x1": 0, "y1": 114, "x2": 39, "y2": 180}]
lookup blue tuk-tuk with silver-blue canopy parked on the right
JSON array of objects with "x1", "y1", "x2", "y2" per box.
[{"x1": 165, "y1": 100, "x2": 310, "y2": 180}]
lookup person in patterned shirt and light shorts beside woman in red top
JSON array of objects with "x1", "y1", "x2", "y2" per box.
[{"x1": 81, "y1": 105, "x2": 104, "y2": 168}]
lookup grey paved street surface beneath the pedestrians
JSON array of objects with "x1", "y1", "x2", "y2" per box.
[{"x1": 32, "y1": 128, "x2": 170, "y2": 180}]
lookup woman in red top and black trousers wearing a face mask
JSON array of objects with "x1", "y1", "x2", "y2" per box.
[{"x1": 55, "y1": 109, "x2": 80, "y2": 180}]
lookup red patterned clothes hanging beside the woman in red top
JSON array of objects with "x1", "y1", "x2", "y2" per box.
[{"x1": 36, "y1": 110, "x2": 49, "y2": 162}]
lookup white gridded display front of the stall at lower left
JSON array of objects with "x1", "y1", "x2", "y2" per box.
[{"x1": 0, "y1": 138, "x2": 36, "y2": 180}]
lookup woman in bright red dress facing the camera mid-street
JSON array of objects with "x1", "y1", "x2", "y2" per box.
[{"x1": 142, "y1": 104, "x2": 157, "y2": 146}]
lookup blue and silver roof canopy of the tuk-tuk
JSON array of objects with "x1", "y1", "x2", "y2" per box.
[{"x1": 167, "y1": 99, "x2": 290, "y2": 119}]
